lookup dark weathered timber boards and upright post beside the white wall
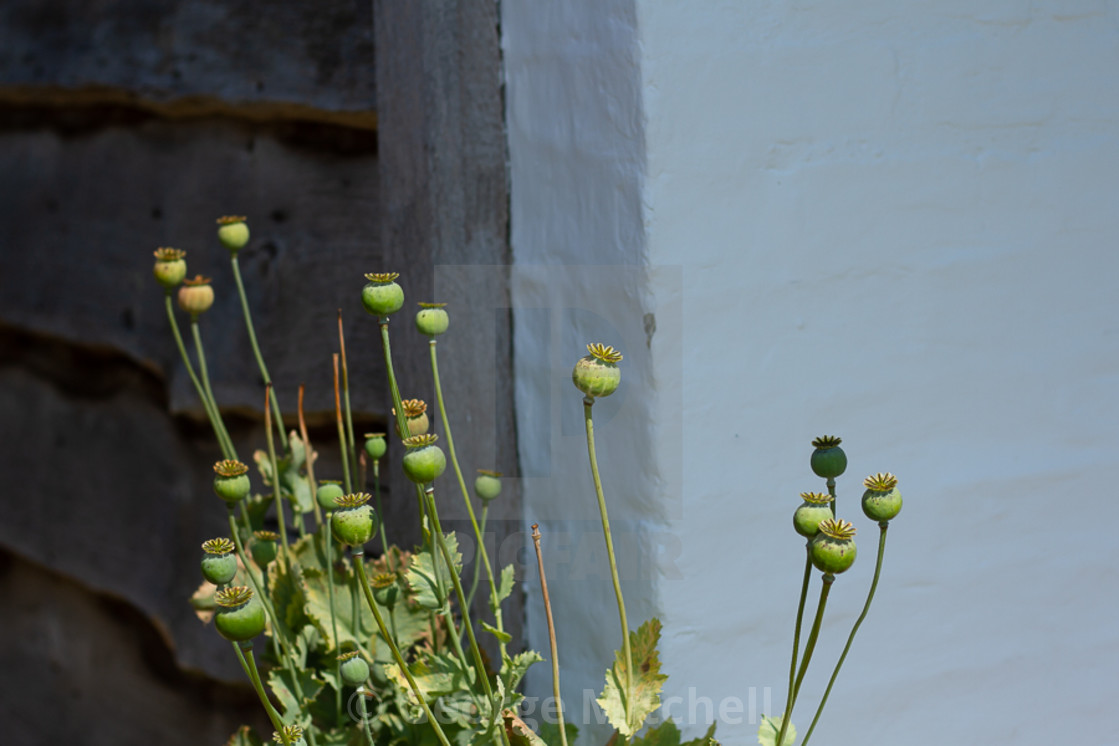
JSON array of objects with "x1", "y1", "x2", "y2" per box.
[{"x1": 0, "y1": 0, "x2": 519, "y2": 744}]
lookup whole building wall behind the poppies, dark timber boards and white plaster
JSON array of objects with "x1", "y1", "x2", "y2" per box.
[{"x1": 0, "y1": 0, "x2": 1119, "y2": 745}]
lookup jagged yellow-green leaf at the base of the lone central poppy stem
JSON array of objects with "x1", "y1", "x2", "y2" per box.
[{"x1": 596, "y1": 618, "x2": 668, "y2": 738}]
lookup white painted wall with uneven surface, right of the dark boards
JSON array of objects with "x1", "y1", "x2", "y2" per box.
[{"x1": 502, "y1": 0, "x2": 1119, "y2": 746}]
